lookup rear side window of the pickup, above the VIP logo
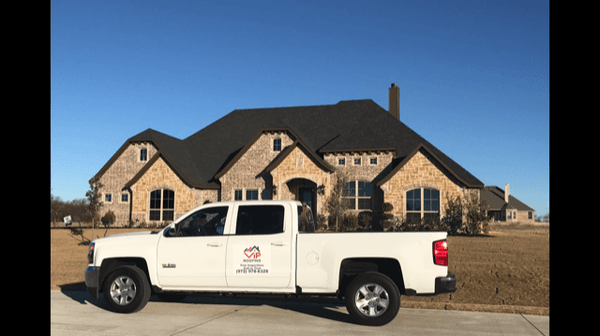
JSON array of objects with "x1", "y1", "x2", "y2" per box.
[{"x1": 235, "y1": 205, "x2": 284, "y2": 235}]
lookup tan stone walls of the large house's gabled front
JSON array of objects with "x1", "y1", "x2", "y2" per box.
[{"x1": 100, "y1": 132, "x2": 482, "y2": 226}]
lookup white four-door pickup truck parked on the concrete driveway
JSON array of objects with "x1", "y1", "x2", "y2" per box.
[{"x1": 85, "y1": 201, "x2": 456, "y2": 325}]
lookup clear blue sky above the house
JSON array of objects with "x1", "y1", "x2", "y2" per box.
[{"x1": 50, "y1": 0, "x2": 550, "y2": 215}]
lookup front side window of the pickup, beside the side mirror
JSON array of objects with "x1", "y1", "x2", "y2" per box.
[{"x1": 175, "y1": 207, "x2": 229, "y2": 237}]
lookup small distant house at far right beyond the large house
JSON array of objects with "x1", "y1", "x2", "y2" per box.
[{"x1": 481, "y1": 183, "x2": 535, "y2": 223}]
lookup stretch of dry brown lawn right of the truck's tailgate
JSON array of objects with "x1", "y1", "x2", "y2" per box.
[{"x1": 402, "y1": 228, "x2": 550, "y2": 315}]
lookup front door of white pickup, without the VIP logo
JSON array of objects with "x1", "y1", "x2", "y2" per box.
[{"x1": 157, "y1": 206, "x2": 229, "y2": 288}]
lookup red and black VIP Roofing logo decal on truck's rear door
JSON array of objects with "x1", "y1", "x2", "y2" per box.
[{"x1": 233, "y1": 245, "x2": 271, "y2": 275}]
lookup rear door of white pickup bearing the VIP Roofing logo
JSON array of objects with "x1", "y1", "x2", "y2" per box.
[{"x1": 226, "y1": 205, "x2": 292, "y2": 288}]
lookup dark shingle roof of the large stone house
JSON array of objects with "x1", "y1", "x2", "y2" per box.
[{"x1": 96, "y1": 99, "x2": 483, "y2": 188}]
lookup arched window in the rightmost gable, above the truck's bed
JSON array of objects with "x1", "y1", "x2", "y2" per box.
[{"x1": 406, "y1": 188, "x2": 440, "y2": 223}]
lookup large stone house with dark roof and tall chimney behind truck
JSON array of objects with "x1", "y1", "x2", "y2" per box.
[{"x1": 95, "y1": 84, "x2": 483, "y2": 225}]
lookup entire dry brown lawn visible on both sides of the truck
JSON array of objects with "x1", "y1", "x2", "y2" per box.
[{"x1": 50, "y1": 226, "x2": 550, "y2": 315}]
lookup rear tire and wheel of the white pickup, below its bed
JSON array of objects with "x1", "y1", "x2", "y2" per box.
[{"x1": 346, "y1": 272, "x2": 400, "y2": 326}]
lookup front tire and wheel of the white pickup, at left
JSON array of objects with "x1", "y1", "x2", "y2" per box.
[{"x1": 104, "y1": 265, "x2": 151, "y2": 313}]
